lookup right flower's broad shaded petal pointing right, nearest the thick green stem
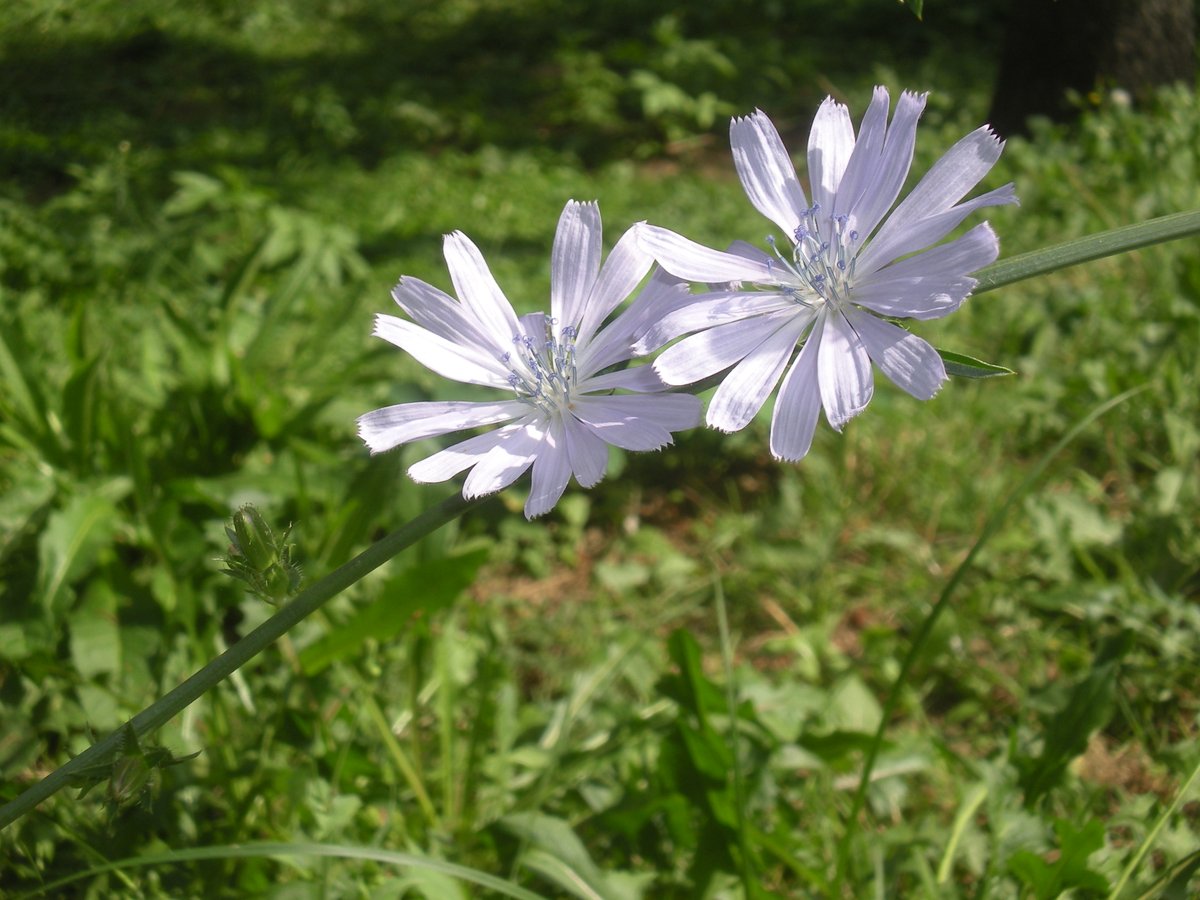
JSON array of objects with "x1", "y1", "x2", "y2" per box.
[{"x1": 851, "y1": 222, "x2": 1000, "y2": 319}]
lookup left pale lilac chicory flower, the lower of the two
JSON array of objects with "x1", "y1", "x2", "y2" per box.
[{"x1": 359, "y1": 200, "x2": 701, "y2": 518}]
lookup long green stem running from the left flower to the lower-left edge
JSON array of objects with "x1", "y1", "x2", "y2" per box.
[{"x1": 0, "y1": 494, "x2": 481, "y2": 828}]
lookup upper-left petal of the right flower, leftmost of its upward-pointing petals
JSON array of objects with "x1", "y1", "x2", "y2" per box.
[{"x1": 730, "y1": 109, "x2": 809, "y2": 239}]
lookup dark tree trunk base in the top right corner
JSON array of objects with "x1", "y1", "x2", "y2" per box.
[{"x1": 989, "y1": 0, "x2": 1196, "y2": 136}]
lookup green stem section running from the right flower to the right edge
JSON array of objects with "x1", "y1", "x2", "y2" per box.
[{"x1": 972, "y1": 210, "x2": 1200, "y2": 294}]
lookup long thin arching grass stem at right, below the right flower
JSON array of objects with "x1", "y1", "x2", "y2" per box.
[{"x1": 838, "y1": 385, "x2": 1147, "y2": 877}]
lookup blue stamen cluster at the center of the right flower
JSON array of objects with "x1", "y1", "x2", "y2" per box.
[{"x1": 767, "y1": 203, "x2": 858, "y2": 306}]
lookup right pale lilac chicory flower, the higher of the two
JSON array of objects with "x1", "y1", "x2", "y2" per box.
[{"x1": 637, "y1": 88, "x2": 1016, "y2": 460}]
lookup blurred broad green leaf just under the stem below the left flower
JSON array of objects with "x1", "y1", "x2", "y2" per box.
[{"x1": 300, "y1": 550, "x2": 487, "y2": 674}]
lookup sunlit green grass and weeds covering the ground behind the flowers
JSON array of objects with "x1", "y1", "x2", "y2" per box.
[{"x1": 0, "y1": 0, "x2": 1200, "y2": 898}]
